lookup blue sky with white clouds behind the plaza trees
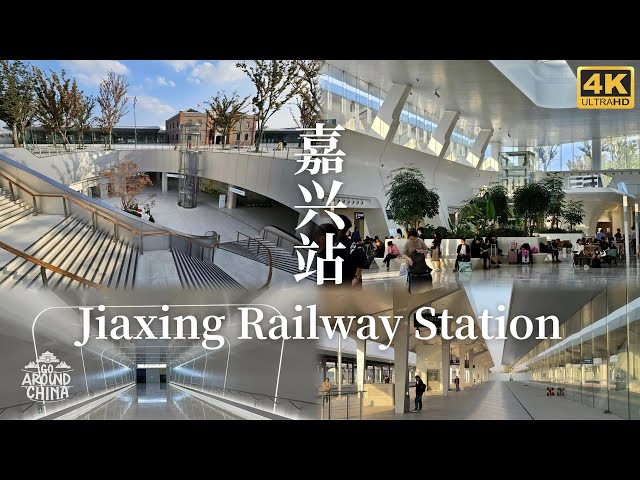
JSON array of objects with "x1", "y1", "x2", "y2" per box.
[{"x1": 26, "y1": 60, "x2": 295, "y2": 128}]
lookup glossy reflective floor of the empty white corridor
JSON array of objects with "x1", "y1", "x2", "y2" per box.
[{"x1": 79, "y1": 383, "x2": 237, "y2": 420}]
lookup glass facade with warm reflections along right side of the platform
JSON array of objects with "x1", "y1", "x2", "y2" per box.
[{"x1": 521, "y1": 284, "x2": 640, "y2": 420}]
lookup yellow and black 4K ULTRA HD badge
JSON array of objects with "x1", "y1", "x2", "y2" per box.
[{"x1": 578, "y1": 67, "x2": 635, "y2": 110}]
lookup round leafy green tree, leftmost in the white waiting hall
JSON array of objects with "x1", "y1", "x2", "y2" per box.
[{"x1": 385, "y1": 164, "x2": 440, "y2": 230}]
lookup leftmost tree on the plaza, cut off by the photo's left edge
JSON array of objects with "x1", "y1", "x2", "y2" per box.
[{"x1": 0, "y1": 60, "x2": 36, "y2": 147}]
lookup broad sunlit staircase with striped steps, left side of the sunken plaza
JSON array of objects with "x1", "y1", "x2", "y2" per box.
[{"x1": 0, "y1": 217, "x2": 138, "y2": 289}]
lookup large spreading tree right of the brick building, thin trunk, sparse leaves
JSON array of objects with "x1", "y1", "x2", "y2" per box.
[{"x1": 236, "y1": 60, "x2": 300, "y2": 152}]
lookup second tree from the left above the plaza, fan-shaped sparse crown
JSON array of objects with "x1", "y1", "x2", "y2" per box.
[{"x1": 33, "y1": 67, "x2": 82, "y2": 150}]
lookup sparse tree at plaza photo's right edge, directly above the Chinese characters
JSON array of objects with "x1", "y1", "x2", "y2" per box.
[{"x1": 292, "y1": 60, "x2": 324, "y2": 128}]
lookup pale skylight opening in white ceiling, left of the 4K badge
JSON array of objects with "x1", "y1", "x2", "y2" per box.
[{"x1": 489, "y1": 60, "x2": 577, "y2": 108}]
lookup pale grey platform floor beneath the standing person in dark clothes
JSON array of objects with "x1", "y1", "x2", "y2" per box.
[{"x1": 364, "y1": 382, "x2": 620, "y2": 420}]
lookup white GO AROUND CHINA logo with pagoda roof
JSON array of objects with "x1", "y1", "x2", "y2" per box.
[{"x1": 22, "y1": 351, "x2": 73, "y2": 402}]
